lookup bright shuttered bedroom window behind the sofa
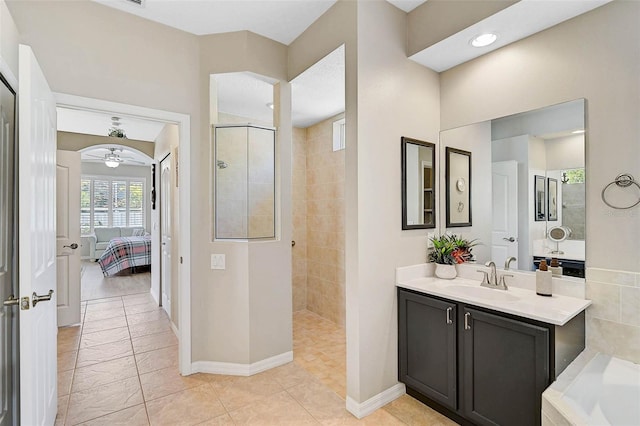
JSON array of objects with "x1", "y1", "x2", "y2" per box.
[{"x1": 80, "y1": 176, "x2": 146, "y2": 235}]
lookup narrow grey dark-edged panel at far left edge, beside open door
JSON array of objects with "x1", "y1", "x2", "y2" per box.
[{"x1": 0, "y1": 75, "x2": 19, "y2": 426}]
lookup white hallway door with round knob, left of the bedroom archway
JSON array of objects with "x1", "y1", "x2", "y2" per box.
[{"x1": 56, "y1": 151, "x2": 80, "y2": 327}]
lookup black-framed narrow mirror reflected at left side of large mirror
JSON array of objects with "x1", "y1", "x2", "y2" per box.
[{"x1": 445, "y1": 147, "x2": 472, "y2": 228}]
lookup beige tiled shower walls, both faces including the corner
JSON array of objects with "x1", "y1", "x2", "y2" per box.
[{"x1": 293, "y1": 114, "x2": 348, "y2": 326}]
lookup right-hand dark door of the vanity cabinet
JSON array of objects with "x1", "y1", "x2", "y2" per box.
[{"x1": 461, "y1": 307, "x2": 549, "y2": 426}]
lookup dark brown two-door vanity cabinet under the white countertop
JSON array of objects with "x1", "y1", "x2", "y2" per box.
[{"x1": 398, "y1": 288, "x2": 572, "y2": 426}]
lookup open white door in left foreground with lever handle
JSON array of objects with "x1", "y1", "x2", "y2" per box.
[{"x1": 18, "y1": 45, "x2": 58, "y2": 426}]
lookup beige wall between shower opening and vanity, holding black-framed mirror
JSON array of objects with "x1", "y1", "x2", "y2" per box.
[{"x1": 346, "y1": 1, "x2": 440, "y2": 402}]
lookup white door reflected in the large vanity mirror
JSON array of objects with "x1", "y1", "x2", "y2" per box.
[{"x1": 491, "y1": 161, "x2": 518, "y2": 265}]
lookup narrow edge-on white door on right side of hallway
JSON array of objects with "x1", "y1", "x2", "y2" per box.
[{"x1": 160, "y1": 155, "x2": 171, "y2": 318}]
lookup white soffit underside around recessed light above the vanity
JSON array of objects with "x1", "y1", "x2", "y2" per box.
[{"x1": 410, "y1": 0, "x2": 611, "y2": 72}]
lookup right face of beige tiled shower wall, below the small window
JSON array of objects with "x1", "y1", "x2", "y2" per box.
[{"x1": 306, "y1": 114, "x2": 349, "y2": 327}]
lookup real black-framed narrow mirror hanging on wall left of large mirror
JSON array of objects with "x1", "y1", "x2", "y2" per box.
[{"x1": 401, "y1": 137, "x2": 437, "y2": 229}]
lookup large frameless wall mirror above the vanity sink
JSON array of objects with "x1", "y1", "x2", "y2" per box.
[{"x1": 439, "y1": 99, "x2": 589, "y2": 277}]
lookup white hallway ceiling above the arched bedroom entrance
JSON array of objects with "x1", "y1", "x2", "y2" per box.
[{"x1": 56, "y1": 107, "x2": 165, "y2": 142}]
